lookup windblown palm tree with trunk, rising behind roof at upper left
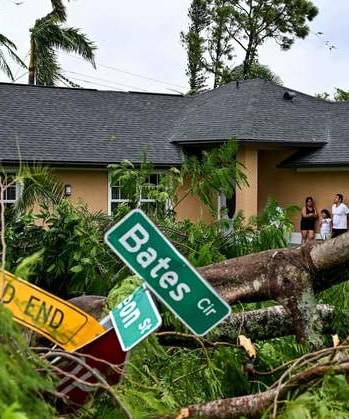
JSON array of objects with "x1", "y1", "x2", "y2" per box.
[{"x1": 28, "y1": 0, "x2": 96, "y2": 86}]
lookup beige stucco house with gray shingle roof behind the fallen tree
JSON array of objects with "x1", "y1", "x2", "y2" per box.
[{"x1": 0, "y1": 79, "x2": 349, "y2": 233}]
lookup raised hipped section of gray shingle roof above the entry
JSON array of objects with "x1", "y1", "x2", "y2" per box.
[{"x1": 172, "y1": 79, "x2": 328, "y2": 145}]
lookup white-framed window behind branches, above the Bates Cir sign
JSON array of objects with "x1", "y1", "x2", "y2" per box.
[{"x1": 109, "y1": 173, "x2": 164, "y2": 213}]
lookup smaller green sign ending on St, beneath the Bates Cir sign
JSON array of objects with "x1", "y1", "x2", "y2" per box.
[{"x1": 109, "y1": 286, "x2": 161, "y2": 352}]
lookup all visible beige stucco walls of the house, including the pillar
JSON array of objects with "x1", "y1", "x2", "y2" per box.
[{"x1": 49, "y1": 153, "x2": 349, "y2": 235}]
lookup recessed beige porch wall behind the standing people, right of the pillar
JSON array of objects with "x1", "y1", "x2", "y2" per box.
[{"x1": 258, "y1": 150, "x2": 349, "y2": 231}]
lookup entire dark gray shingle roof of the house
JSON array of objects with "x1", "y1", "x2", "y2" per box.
[{"x1": 0, "y1": 80, "x2": 349, "y2": 167}]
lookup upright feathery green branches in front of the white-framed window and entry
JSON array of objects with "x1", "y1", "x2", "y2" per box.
[{"x1": 110, "y1": 139, "x2": 247, "y2": 220}]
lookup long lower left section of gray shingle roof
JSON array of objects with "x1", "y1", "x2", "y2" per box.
[{"x1": 0, "y1": 84, "x2": 186, "y2": 165}]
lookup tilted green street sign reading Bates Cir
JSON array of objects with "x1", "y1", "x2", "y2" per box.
[{"x1": 105, "y1": 210, "x2": 230, "y2": 336}]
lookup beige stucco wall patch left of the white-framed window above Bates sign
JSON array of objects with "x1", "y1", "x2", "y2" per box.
[{"x1": 55, "y1": 169, "x2": 108, "y2": 212}]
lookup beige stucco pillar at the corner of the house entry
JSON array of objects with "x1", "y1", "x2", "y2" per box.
[{"x1": 236, "y1": 147, "x2": 258, "y2": 220}]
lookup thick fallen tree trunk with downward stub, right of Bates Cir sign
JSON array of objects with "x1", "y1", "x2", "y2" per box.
[{"x1": 198, "y1": 233, "x2": 349, "y2": 346}]
